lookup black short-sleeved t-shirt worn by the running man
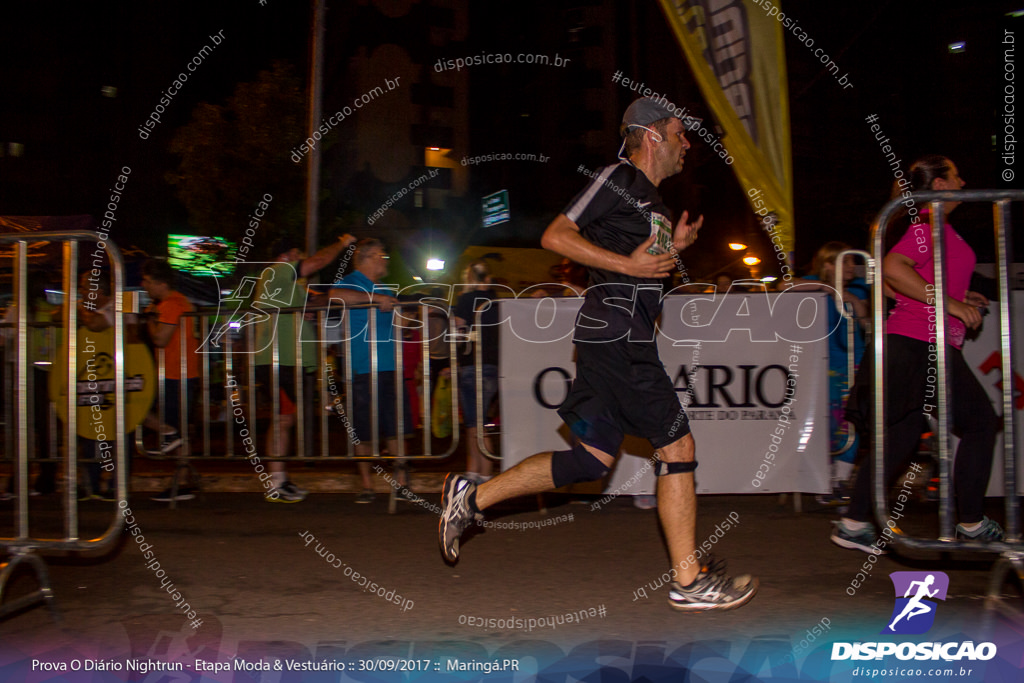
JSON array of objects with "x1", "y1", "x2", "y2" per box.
[{"x1": 564, "y1": 162, "x2": 672, "y2": 342}]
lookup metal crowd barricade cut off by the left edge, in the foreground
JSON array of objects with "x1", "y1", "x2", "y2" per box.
[{"x1": 0, "y1": 231, "x2": 128, "y2": 621}]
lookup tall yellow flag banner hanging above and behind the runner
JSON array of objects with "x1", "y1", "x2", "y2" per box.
[{"x1": 660, "y1": 0, "x2": 794, "y2": 260}]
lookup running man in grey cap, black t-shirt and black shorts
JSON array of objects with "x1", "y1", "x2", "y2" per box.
[{"x1": 438, "y1": 97, "x2": 758, "y2": 610}]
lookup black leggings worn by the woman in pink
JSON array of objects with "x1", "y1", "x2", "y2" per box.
[{"x1": 847, "y1": 335, "x2": 1000, "y2": 524}]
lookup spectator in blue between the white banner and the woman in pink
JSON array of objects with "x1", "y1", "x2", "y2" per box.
[{"x1": 793, "y1": 242, "x2": 870, "y2": 505}]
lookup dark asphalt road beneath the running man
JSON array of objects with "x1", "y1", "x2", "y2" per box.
[{"x1": 0, "y1": 493, "x2": 1024, "y2": 681}]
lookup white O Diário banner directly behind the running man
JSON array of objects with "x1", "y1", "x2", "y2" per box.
[{"x1": 500, "y1": 292, "x2": 830, "y2": 494}]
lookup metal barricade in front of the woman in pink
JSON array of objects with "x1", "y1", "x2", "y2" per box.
[{"x1": 872, "y1": 189, "x2": 1024, "y2": 610}]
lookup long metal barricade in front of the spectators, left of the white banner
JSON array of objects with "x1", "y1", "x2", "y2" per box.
[{"x1": 135, "y1": 303, "x2": 459, "y2": 467}]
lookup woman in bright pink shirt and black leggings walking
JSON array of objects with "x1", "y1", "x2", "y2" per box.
[{"x1": 831, "y1": 155, "x2": 1004, "y2": 553}]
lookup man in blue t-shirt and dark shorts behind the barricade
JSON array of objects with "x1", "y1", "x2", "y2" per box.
[{"x1": 330, "y1": 238, "x2": 413, "y2": 503}]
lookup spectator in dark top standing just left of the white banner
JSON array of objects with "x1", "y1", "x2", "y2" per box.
[{"x1": 453, "y1": 261, "x2": 500, "y2": 483}]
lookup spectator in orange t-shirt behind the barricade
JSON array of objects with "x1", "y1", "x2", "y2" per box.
[{"x1": 141, "y1": 258, "x2": 200, "y2": 503}]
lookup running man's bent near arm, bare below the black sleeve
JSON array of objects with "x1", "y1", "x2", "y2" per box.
[{"x1": 541, "y1": 213, "x2": 675, "y2": 278}]
